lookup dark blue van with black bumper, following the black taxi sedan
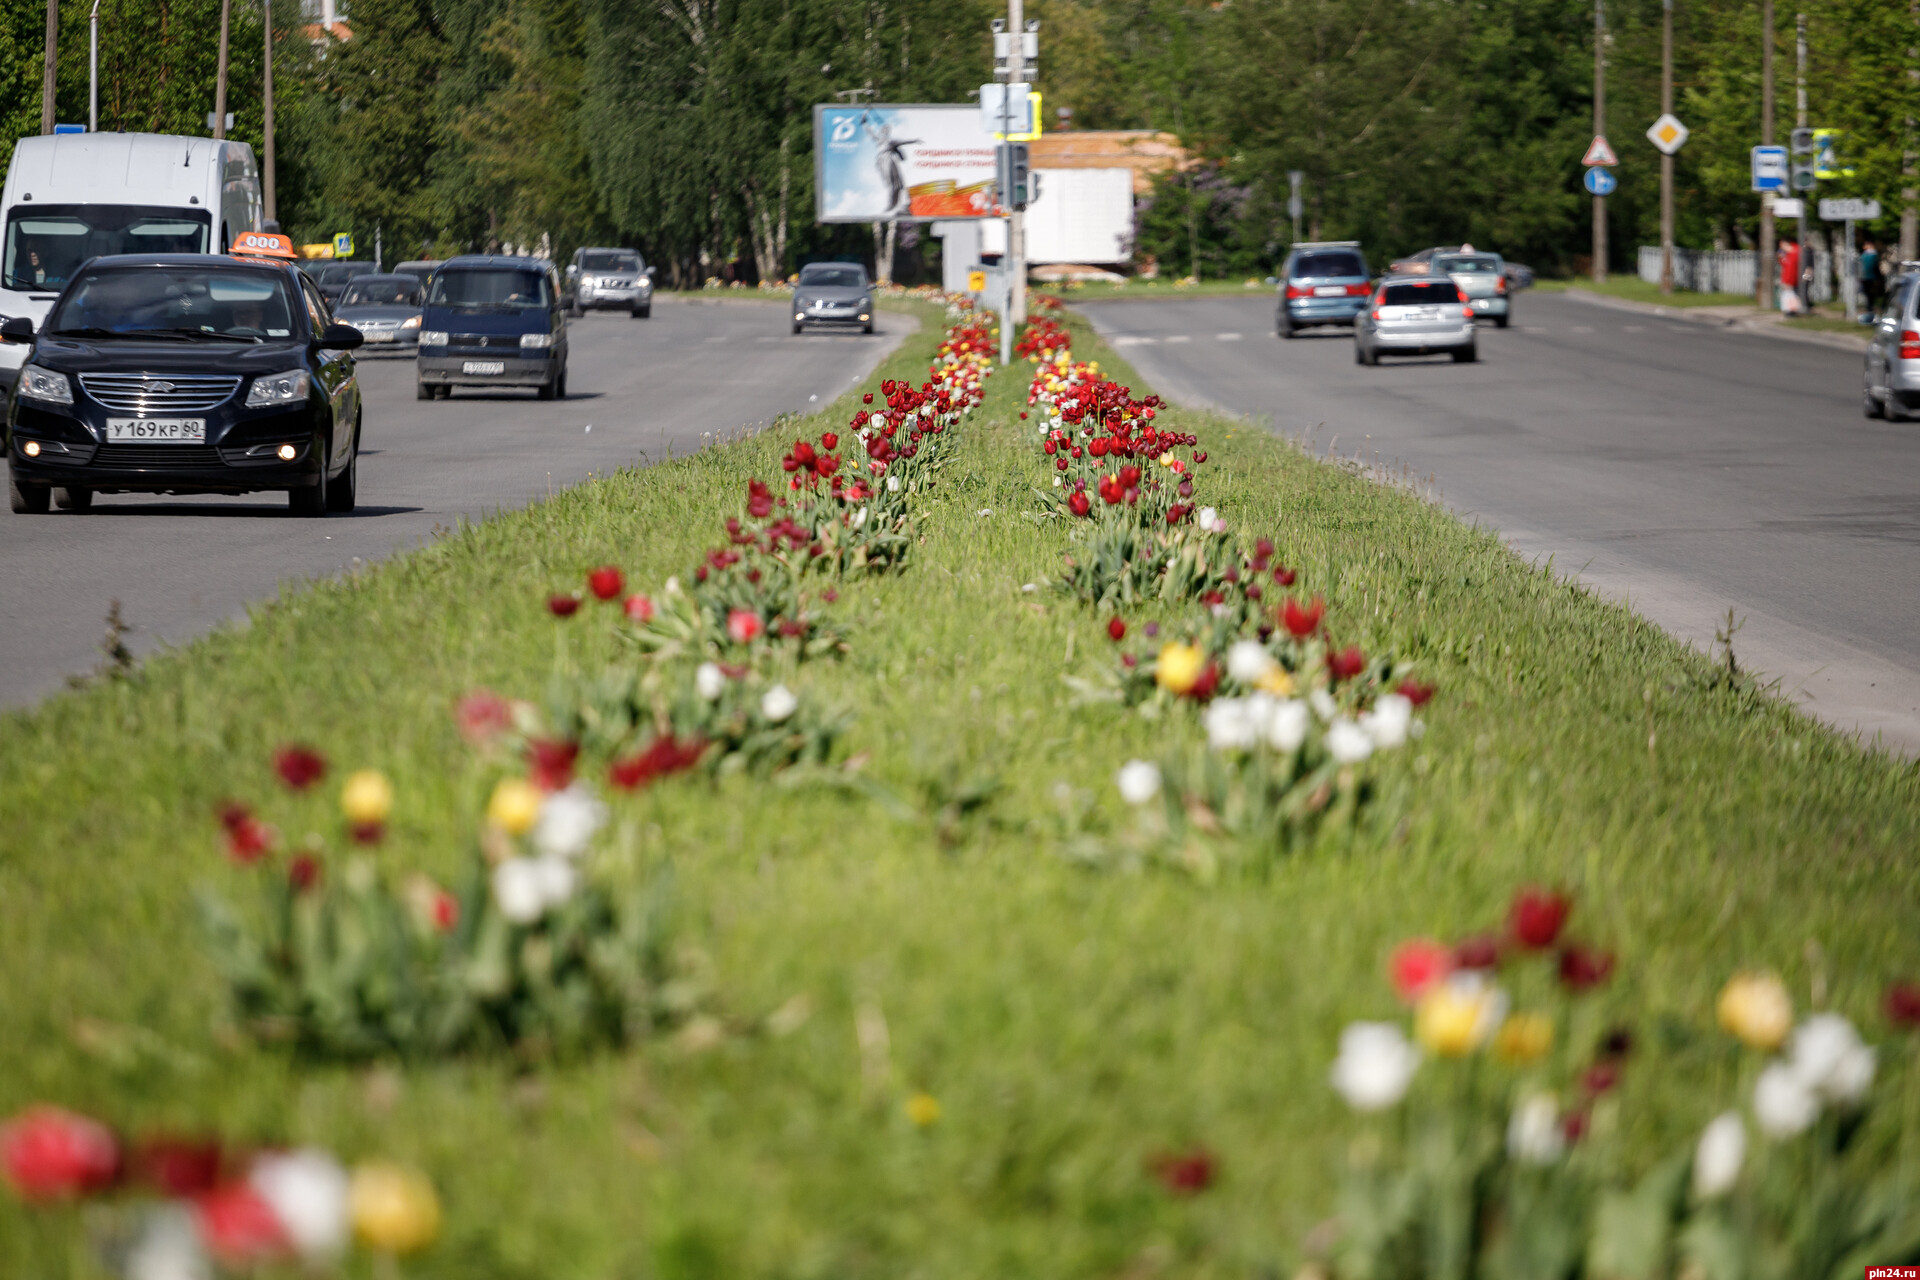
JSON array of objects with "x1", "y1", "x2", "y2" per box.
[{"x1": 415, "y1": 253, "x2": 566, "y2": 399}]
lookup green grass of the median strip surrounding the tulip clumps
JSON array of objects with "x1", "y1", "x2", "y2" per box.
[{"x1": 0, "y1": 297, "x2": 1920, "y2": 1280}]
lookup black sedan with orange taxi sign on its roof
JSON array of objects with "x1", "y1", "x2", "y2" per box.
[{"x1": 0, "y1": 253, "x2": 361, "y2": 516}]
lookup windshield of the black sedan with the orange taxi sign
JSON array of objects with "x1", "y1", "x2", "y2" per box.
[{"x1": 46, "y1": 265, "x2": 294, "y2": 338}]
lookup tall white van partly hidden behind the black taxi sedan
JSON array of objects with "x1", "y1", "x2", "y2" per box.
[{"x1": 0, "y1": 132, "x2": 261, "y2": 391}]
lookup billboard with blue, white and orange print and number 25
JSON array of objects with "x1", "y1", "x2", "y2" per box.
[{"x1": 814, "y1": 104, "x2": 1006, "y2": 223}]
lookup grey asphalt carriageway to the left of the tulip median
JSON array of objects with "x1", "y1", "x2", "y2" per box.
[{"x1": 0, "y1": 297, "x2": 916, "y2": 706}]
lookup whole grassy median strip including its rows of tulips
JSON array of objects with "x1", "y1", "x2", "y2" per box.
[{"x1": 0, "y1": 293, "x2": 1920, "y2": 1280}]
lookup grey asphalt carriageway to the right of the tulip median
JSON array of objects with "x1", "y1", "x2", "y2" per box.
[{"x1": 1083, "y1": 290, "x2": 1920, "y2": 754}]
